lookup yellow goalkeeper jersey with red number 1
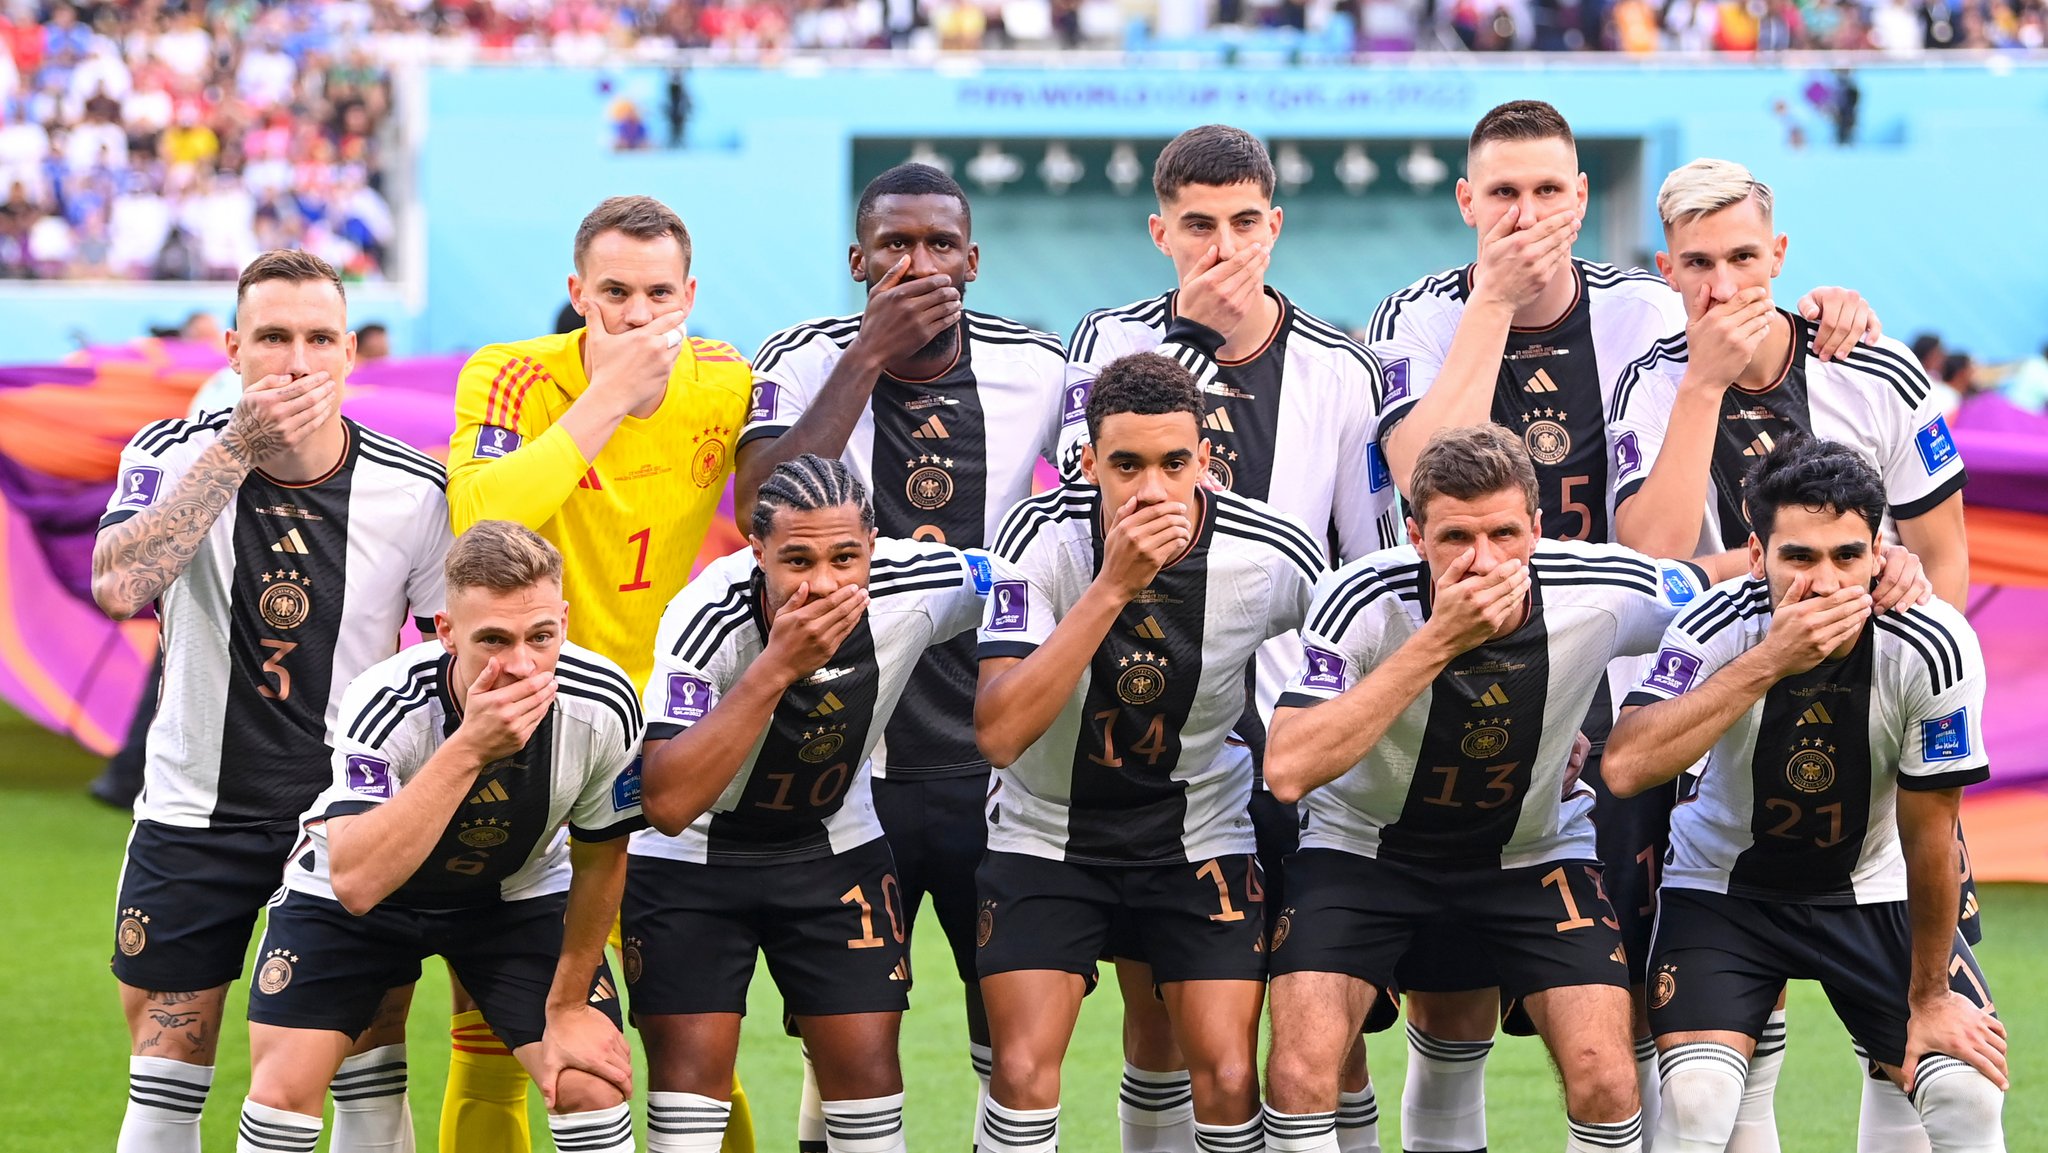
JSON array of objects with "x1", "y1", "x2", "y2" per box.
[{"x1": 449, "y1": 330, "x2": 752, "y2": 688}]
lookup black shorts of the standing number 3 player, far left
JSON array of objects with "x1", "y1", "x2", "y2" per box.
[{"x1": 113, "y1": 821, "x2": 299, "y2": 993}]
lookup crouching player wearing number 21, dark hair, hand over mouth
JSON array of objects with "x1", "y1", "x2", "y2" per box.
[{"x1": 1606, "y1": 438, "x2": 2007, "y2": 1153}]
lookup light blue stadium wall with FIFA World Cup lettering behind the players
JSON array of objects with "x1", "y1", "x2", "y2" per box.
[{"x1": 0, "y1": 61, "x2": 2048, "y2": 360}]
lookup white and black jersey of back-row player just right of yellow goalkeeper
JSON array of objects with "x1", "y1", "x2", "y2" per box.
[{"x1": 739, "y1": 311, "x2": 1065, "y2": 778}]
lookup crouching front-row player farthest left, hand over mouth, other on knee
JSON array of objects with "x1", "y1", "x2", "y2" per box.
[{"x1": 236, "y1": 520, "x2": 641, "y2": 1153}]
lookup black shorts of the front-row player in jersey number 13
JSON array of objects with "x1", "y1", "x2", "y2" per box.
[{"x1": 1272, "y1": 848, "x2": 1628, "y2": 997}]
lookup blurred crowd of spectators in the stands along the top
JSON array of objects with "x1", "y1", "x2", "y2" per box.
[{"x1": 0, "y1": 0, "x2": 2048, "y2": 281}]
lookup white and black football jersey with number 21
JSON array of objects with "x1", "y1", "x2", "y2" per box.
[{"x1": 1622, "y1": 578, "x2": 1991, "y2": 905}]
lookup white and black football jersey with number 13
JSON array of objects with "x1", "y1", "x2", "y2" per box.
[{"x1": 1280, "y1": 541, "x2": 1704, "y2": 868}]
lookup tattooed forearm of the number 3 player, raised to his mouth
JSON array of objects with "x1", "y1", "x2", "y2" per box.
[{"x1": 92, "y1": 373, "x2": 336, "y2": 621}]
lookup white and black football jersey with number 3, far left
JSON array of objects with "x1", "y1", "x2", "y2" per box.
[{"x1": 100, "y1": 412, "x2": 451, "y2": 827}]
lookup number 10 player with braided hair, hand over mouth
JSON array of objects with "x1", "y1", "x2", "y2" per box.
[{"x1": 623, "y1": 453, "x2": 989, "y2": 1153}]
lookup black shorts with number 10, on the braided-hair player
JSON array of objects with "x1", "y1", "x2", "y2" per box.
[{"x1": 618, "y1": 838, "x2": 909, "y2": 1018}]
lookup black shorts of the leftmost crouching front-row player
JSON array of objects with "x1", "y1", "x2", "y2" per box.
[{"x1": 250, "y1": 889, "x2": 621, "y2": 1049}]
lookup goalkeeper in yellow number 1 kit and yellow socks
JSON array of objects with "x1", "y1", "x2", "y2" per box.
[{"x1": 440, "y1": 197, "x2": 754, "y2": 1153}]
